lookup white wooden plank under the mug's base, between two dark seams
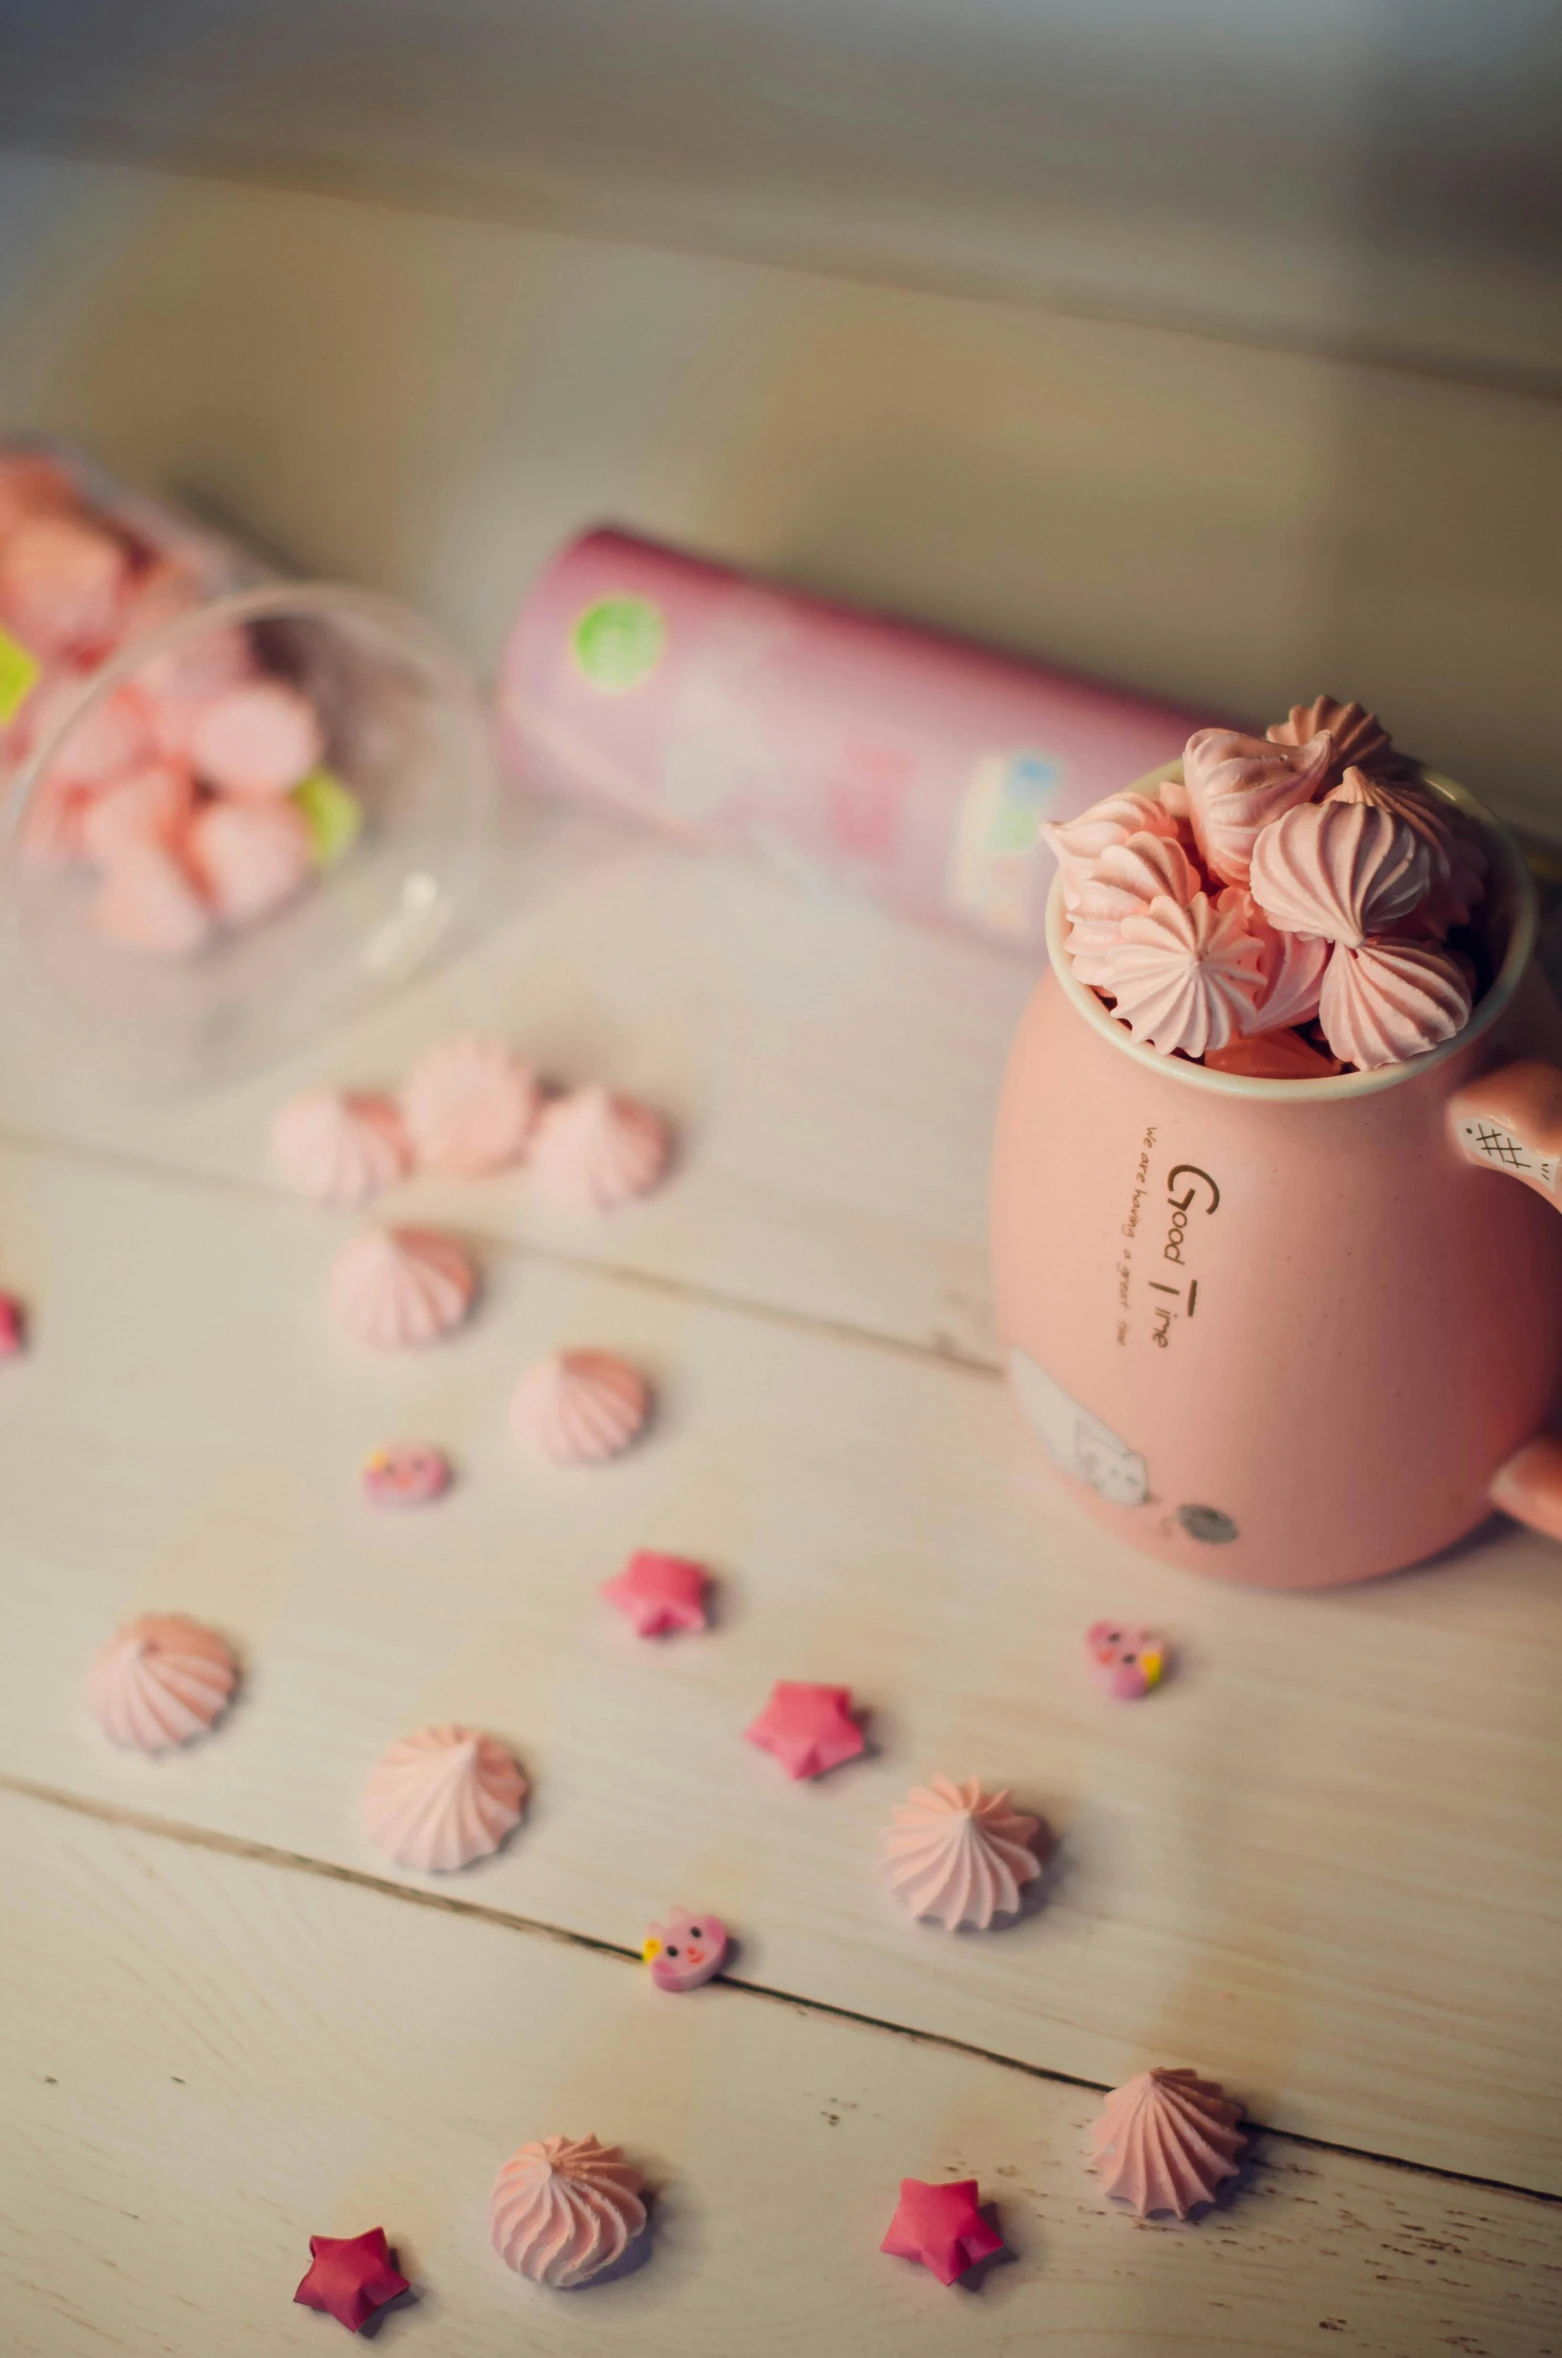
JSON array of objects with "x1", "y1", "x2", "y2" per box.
[{"x1": 0, "y1": 1153, "x2": 1562, "y2": 2191}]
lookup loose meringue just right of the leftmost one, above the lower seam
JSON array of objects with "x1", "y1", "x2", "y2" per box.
[{"x1": 363, "y1": 1726, "x2": 526, "y2": 1875}]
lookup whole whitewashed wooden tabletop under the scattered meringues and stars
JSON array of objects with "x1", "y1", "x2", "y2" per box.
[{"x1": 0, "y1": 801, "x2": 1562, "y2": 2358}]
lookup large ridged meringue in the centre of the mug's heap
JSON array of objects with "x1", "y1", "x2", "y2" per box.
[{"x1": 1253, "y1": 802, "x2": 1432, "y2": 948}]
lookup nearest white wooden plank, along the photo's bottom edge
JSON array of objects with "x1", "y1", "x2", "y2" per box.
[{"x1": 0, "y1": 1794, "x2": 1562, "y2": 2358}]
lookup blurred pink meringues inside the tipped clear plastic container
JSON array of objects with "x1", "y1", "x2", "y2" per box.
[{"x1": 0, "y1": 453, "x2": 346, "y2": 957}]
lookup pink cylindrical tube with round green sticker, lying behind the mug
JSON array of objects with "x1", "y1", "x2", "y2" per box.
[{"x1": 498, "y1": 531, "x2": 1210, "y2": 955}]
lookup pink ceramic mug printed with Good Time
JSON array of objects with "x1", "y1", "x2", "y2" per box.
[{"x1": 993, "y1": 764, "x2": 1562, "y2": 1587}]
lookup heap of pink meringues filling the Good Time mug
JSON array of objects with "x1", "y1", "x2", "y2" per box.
[{"x1": 1041, "y1": 696, "x2": 1489, "y2": 1080}]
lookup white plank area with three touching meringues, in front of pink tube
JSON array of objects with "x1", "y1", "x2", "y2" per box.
[{"x1": 0, "y1": 811, "x2": 1033, "y2": 1358}]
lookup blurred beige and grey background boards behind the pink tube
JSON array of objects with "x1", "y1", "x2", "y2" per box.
[{"x1": 0, "y1": 0, "x2": 1562, "y2": 825}]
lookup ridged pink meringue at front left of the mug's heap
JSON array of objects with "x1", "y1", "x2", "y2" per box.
[{"x1": 1100, "y1": 894, "x2": 1265, "y2": 1056}]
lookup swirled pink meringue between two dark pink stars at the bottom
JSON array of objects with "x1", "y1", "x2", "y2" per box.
[{"x1": 488, "y1": 2136, "x2": 647, "y2": 2292}]
